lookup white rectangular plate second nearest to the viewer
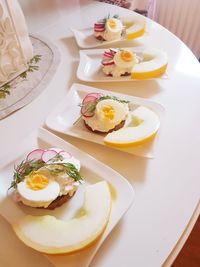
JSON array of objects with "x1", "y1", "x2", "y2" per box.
[{"x1": 46, "y1": 83, "x2": 164, "y2": 158}]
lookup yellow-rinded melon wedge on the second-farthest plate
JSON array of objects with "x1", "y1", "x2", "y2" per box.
[{"x1": 131, "y1": 49, "x2": 168, "y2": 79}]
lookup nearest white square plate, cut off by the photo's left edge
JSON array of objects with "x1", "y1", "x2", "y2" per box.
[{"x1": 0, "y1": 129, "x2": 134, "y2": 267}]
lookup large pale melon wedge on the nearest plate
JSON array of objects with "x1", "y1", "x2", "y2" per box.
[{"x1": 13, "y1": 181, "x2": 111, "y2": 254}]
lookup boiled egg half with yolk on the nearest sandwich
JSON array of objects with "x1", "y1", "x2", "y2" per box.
[{"x1": 17, "y1": 171, "x2": 60, "y2": 207}]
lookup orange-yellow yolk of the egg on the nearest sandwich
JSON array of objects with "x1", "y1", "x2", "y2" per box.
[{"x1": 26, "y1": 172, "x2": 49, "y2": 190}]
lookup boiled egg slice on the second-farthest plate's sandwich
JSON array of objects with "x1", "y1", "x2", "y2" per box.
[{"x1": 114, "y1": 50, "x2": 137, "y2": 68}]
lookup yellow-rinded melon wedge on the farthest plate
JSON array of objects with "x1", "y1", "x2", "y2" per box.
[{"x1": 121, "y1": 14, "x2": 146, "y2": 40}]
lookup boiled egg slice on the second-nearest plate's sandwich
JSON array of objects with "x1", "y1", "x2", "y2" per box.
[{"x1": 96, "y1": 99, "x2": 128, "y2": 125}]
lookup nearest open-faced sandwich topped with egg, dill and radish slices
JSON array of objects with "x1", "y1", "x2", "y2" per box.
[{"x1": 11, "y1": 148, "x2": 82, "y2": 209}]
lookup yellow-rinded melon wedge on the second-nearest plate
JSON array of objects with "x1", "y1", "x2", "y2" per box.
[{"x1": 104, "y1": 106, "x2": 160, "y2": 147}]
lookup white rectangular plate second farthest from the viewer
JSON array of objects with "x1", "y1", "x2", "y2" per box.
[{"x1": 77, "y1": 47, "x2": 167, "y2": 82}]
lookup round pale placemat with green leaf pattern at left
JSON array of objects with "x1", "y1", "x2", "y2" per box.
[{"x1": 0, "y1": 35, "x2": 60, "y2": 119}]
